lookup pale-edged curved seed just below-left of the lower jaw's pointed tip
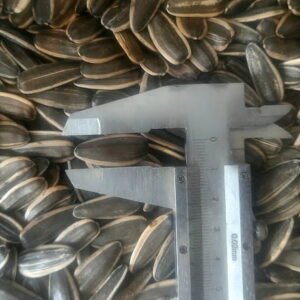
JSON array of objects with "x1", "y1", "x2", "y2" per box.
[{"x1": 25, "y1": 185, "x2": 73, "y2": 221}]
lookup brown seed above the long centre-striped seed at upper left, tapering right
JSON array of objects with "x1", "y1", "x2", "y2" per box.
[{"x1": 34, "y1": 29, "x2": 81, "y2": 60}]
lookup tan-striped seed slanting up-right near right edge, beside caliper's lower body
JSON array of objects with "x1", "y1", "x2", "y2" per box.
[{"x1": 258, "y1": 219, "x2": 294, "y2": 268}]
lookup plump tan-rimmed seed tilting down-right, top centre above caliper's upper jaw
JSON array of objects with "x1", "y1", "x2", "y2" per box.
[{"x1": 148, "y1": 12, "x2": 191, "y2": 65}]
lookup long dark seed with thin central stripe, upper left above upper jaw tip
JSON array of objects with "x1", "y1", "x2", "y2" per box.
[{"x1": 18, "y1": 61, "x2": 80, "y2": 94}]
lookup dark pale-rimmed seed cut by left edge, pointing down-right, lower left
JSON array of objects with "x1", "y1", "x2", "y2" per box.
[{"x1": 0, "y1": 213, "x2": 23, "y2": 244}]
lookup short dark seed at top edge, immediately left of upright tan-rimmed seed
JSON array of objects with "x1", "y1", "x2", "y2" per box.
[{"x1": 101, "y1": 0, "x2": 130, "y2": 32}]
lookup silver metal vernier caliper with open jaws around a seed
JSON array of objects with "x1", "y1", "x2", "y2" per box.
[{"x1": 64, "y1": 84, "x2": 290, "y2": 300}]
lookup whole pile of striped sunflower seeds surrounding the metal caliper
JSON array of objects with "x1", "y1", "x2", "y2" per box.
[{"x1": 0, "y1": 0, "x2": 300, "y2": 300}]
